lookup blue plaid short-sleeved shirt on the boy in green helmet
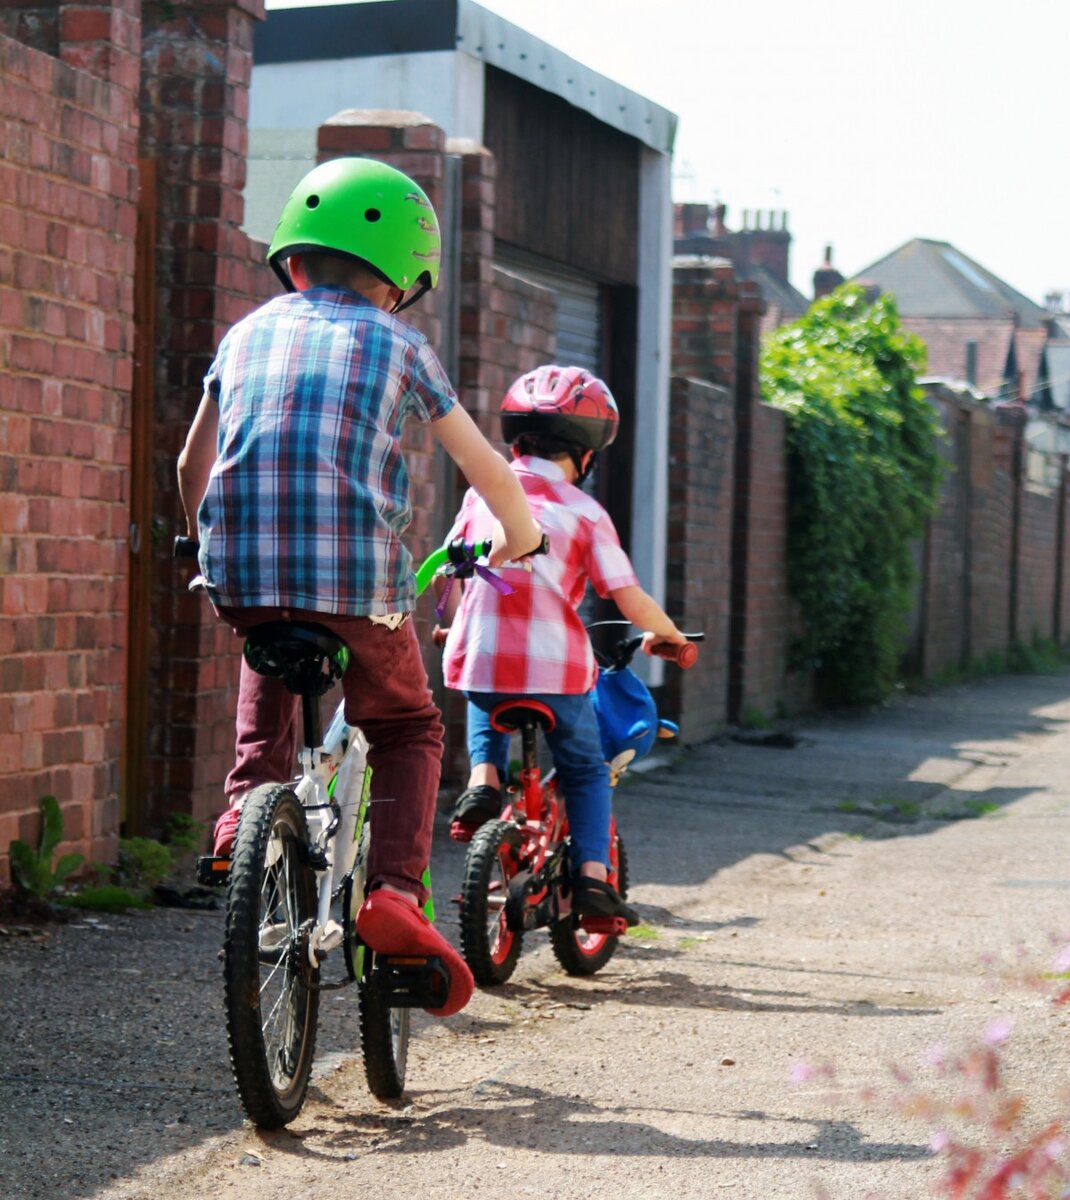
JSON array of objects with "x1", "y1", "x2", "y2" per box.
[{"x1": 198, "y1": 288, "x2": 456, "y2": 616}]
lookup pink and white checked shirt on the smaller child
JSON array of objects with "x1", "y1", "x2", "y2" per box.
[{"x1": 445, "y1": 457, "x2": 638, "y2": 696}]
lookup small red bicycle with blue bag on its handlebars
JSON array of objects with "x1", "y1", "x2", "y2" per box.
[{"x1": 461, "y1": 622, "x2": 703, "y2": 986}]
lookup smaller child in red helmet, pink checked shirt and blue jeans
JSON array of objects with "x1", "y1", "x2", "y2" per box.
[{"x1": 436, "y1": 365, "x2": 686, "y2": 924}]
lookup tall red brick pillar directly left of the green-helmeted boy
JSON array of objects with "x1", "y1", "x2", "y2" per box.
[{"x1": 140, "y1": 0, "x2": 271, "y2": 827}]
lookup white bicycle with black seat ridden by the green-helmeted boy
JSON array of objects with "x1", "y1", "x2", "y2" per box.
[{"x1": 175, "y1": 538, "x2": 450, "y2": 1129}]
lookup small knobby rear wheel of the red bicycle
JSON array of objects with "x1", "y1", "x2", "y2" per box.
[{"x1": 461, "y1": 821, "x2": 523, "y2": 988}]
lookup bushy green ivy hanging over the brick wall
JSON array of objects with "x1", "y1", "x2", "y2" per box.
[{"x1": 761, "y1": 284, "x2": 943, "y2": 704}]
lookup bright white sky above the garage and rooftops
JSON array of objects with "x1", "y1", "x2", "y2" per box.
[{"x1": 261, "y1": 0, "x2": 1070, "y2": 304}]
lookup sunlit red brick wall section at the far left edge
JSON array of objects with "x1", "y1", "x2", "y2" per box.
[{"x1": 0, "y1": 21, "x2": 137, "y2": 877}]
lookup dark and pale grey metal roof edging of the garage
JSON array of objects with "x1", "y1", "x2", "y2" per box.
[{"x1": 253, "y1": 0, "x2": 677, "y2": 154}]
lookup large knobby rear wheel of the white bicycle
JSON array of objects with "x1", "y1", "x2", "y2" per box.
[{"x1": 223, "y1": 784, "x2": 319, "y2": 1129}]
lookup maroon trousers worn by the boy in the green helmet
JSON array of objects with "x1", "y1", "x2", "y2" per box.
[{"x1": 218, "y1": 608, "x2": 443, "y2": 904}]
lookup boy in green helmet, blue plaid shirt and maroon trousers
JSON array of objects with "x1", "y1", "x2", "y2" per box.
[{"x1": 179, "y1": 158, "x2": 542, "y2": 1015}]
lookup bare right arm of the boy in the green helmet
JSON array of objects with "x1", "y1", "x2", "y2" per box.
[{"x1": 431, "y1": 404, "x2": 542, "y2": 566}]
